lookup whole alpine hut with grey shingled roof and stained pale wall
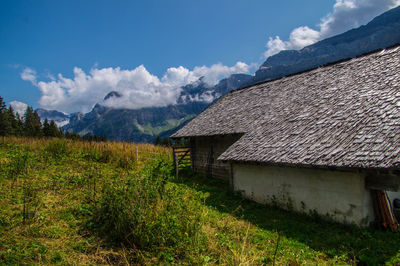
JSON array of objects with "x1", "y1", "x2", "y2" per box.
[{"x1": 173, "y1": 46, "x2": 400, "y2": 225}]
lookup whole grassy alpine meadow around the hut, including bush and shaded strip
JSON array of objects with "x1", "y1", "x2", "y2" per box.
[{"x1": 0, "y1": 138, "x2": 400, "y2": 265}]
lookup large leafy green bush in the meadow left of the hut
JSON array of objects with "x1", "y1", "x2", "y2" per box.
[{"x1": 89, "y1": 160, "x2": 203, "y2": 260}]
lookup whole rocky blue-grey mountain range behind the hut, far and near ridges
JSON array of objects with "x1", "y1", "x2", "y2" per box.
[{"x1": 37, "y1": 7, "x2": 400, "y2": 142}]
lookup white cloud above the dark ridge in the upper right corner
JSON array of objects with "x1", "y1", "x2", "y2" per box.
[{"x1": 264, "y1": 0, "x2": 400, "y2": 58}]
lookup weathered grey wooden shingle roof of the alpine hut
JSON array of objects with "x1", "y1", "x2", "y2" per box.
[{"x1": 173, "y1": 46, "x2": 400, "y2": 168}]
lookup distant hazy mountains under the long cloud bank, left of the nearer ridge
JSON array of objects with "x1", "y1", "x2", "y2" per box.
[{"x1": 62, "y1": 74, "x2": 251, "y2": 142}]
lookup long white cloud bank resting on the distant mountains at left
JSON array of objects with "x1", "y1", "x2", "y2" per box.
[{"x1": 21, "y1": 62, "x2": 254, "y2": 113}]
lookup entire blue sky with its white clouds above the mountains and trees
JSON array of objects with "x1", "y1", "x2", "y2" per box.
[{"x1": 0, "y1": 0, "x2": 398, "y2": 112}]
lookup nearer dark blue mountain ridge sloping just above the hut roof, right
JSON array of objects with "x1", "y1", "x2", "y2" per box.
[{"x1": 252, "y1": 7, "x2": 400, "y2": 85}]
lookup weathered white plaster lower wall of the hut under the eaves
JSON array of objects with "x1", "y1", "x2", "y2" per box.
[{"x1": 233, "y1": 164, "x2": 374, "y2": 226}]
